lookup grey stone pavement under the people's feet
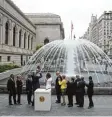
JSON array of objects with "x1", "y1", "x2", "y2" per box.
[{"x1": 0, "y1": 94, "x2": 112, "y2": 116}]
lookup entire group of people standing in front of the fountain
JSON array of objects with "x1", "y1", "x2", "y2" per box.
[{"x1": 7, "y1": 66, "x2": 94, "y2": 108}]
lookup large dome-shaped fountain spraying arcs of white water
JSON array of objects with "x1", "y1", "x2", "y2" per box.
[{"x1": 22, "y1": 39, "x2": 112, "y2": 86}]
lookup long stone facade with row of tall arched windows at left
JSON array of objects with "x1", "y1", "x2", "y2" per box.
[{"x1": 0, "y1": 0, "x2": 36, "y2": 66}]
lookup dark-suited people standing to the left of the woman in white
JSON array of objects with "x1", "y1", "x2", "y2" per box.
[{"x1": 7, "y1": 66, "x2": 42, "y2": 106}]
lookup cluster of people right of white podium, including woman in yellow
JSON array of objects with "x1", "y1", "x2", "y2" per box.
[{"x1": 55, "y1": 72, "x2": 94, "y2": 109}]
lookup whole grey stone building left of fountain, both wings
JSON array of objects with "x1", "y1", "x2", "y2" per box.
[{"x1": 0, "y1": 0, "x2": 64, "y2": 66}]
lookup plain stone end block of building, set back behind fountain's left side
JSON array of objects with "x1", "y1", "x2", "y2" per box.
[{"x1": 26, "y1": 13, "x2": 64, "y2": 45}]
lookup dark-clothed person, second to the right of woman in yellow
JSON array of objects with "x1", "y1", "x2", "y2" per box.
[{"x1": 75, "y1": 75, "x2": 80, "y2": 105}]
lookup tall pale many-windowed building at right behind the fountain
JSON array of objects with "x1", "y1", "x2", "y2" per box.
[{"x1": 82, "y1": 11, "x2": 112, "y2": 57}]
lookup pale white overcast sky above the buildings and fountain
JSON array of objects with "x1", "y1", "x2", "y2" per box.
[{"x1": 12, "y1": 0, "x2": 112, "y2": 38}]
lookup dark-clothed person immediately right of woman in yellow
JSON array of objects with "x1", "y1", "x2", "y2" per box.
[{"x1": 66, "y1": 78, "x2": 74, "y2": 107}]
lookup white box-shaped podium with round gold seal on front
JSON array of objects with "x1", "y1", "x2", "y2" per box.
[{"x1": 34, "y1": 89, "x2": 51, "y2": 111}]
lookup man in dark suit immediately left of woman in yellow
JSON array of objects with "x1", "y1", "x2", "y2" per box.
[{"x1": 55, "y1": 71, "x2": 62, "y2": 103}]
